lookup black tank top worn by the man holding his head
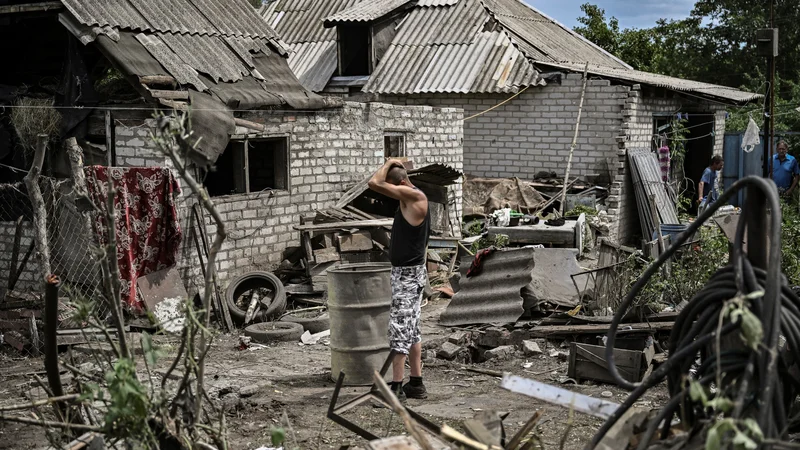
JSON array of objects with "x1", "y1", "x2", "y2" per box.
[{"x1": 389, "y1": 197, "x2": 431, "y2": 267}]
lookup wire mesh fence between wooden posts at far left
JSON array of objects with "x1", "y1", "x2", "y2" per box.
[{"x1": 0, "y1": 177, "x2": 107, "y2": 356}]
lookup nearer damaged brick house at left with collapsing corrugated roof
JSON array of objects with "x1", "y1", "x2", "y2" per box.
[{"x1": 0, "y1": 0, "x2": 463, "y2": 330}]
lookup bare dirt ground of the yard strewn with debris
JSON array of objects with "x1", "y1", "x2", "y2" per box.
[{"x1": 0, "y1": 300, "x2": 667, "y2": 450}]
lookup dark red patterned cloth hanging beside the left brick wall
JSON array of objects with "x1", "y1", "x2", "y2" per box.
[{"x1": 84, "y1": 166, "x2": 182, "y2": 314}]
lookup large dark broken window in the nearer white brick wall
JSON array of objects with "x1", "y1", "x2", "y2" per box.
[{"x1": 204, "y1": 137, "x2": 289, "y2": 197}]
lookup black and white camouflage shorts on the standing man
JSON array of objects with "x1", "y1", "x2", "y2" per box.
[{"x1": 389, "y1": 265, "x2": 428, "y2": 355}]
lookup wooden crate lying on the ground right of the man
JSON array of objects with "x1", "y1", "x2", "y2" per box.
[{"x1": 567, "y1": 342, "x2": 650, "y2": 384}]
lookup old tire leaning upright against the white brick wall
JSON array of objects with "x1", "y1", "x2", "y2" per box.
[{"x1": 225, "y1": 271, "x2": 286, "y2": 325}]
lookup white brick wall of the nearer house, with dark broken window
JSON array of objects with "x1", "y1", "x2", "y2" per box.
[{"x1": 111, "y1": 102, "x2": 464, "y2": 290}]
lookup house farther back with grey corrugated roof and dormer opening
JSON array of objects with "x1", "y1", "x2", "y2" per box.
[{"x1": 261, "y1": 0, "x2": 759, "y2": 241}]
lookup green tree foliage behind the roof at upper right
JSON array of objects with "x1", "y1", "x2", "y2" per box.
[{"x1": 575, "y1": 0, "x2": 800, "y2": 131}]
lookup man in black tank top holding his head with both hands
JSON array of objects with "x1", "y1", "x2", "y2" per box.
[{"x1": 369, "y1": 159, "x2": 431, "y2": 400}]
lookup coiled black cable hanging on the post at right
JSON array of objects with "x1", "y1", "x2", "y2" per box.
[{"x1": 588, "y1": 177, "x2": 788, "y2": 449}]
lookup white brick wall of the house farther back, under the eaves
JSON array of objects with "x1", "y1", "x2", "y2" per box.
[{"x1": 380, "y1": 74, "x2": 725, "y2": 242}]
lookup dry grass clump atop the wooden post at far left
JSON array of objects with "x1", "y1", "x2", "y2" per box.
[{"x1": 11, "y1": 97, "x2": 61, "y2": 151}]
